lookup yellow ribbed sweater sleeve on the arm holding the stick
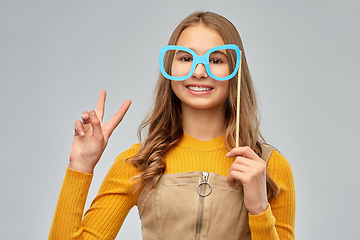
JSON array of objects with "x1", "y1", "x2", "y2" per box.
[{"x1": 249, "y1": 151, "x2": 295, "y2": 240}]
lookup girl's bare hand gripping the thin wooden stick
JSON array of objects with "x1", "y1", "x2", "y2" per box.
[{"x1": 226, "y1": 147, "x2": 269, "y2": 215}]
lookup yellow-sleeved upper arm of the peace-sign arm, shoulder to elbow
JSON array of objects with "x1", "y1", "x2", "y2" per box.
[{"x1": 83, "y1": 144, "x2": 140, "y2": 239}]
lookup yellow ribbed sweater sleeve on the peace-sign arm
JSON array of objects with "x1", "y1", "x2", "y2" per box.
[{"x1": 48, "y1": 145, "x2": 139, "y2": 239}]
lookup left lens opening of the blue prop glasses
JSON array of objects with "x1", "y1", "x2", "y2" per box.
[{"x1": 164, "y1": 50, "x2": 194, "y2": 77}]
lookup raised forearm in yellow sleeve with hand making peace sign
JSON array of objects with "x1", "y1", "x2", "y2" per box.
[{"x1": 49, "y1": 91, "x2": 131, "y2": 239}]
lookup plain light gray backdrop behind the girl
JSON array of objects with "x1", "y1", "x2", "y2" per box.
[{"x1": 0, "y1": 0, "x2": 360, "y2": 239}]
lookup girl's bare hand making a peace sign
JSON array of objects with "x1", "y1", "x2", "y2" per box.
[{"x1": 69, "y1": 90, "x2": 131, "y2": 173}]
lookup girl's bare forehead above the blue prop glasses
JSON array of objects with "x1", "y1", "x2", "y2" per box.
[{"x1": 176, "y1": 24, "x2": 225, "y2": 55}]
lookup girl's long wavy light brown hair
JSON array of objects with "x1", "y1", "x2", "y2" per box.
[{"x1": 129, "y1": 12, "x2": 279, "y2": 198}]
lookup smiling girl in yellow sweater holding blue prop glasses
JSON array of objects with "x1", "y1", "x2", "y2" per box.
[{"x1": 49, "y1": 12, "x2": 295, "y2": 240}]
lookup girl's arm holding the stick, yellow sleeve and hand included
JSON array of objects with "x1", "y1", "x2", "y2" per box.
[{"x1": 227, "y1": 147, "x2": 295, "y2": 240}]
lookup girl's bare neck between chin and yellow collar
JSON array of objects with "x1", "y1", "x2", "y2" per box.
[{"x1": 181, "y1": 105, "x2": 225, "y2": 141}]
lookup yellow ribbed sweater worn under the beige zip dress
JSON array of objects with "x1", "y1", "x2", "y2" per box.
[{"x1": 49, "y1": 134, "x2": 295, "y2": 240}]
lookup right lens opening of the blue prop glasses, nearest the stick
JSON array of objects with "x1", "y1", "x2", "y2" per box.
[{"x1": 209, "y1": 49, "x2": 237, "y2": 78}]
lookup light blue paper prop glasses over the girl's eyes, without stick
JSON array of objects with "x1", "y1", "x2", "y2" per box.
[{"x1": 159, "y1": 44, "x2": 241, "y2": 81}]
